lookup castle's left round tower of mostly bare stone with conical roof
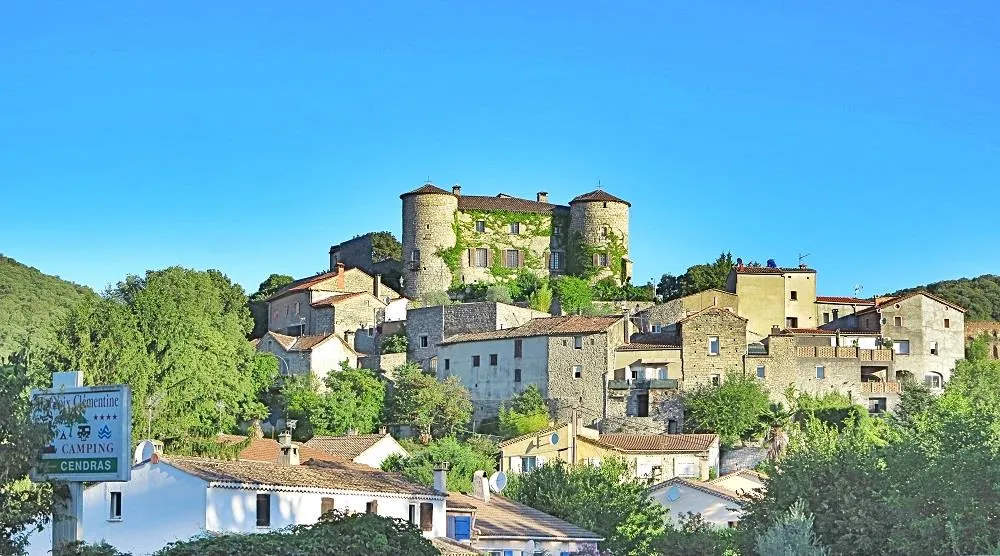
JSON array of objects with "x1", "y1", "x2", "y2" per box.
[{"x1": 399, "y1": 183, "x2": 458, "y2": 299}]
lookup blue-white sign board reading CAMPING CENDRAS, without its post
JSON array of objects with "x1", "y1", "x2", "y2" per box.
[{"x1": 32, "y1": 385, "x2": 132, "y2": 482}]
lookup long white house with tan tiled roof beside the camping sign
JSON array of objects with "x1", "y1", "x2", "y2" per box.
[{"x1": 29, "y1": 439, "x2": 447, "y2": 556}]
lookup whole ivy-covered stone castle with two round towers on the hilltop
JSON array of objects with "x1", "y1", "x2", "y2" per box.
[{"x1": 400, "y1": 183, "x2": 632, "y2": 299}]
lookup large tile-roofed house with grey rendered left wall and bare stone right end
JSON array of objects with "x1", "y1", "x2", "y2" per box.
[{"x1": 437, "y1": 315, "x2": 628, "y2": 423}]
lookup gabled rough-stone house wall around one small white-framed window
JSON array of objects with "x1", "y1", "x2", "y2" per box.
[{"x1": 680, "y1": 308, "x2": 746, "y2": 390}]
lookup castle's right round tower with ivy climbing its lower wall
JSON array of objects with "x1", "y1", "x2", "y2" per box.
[{"x1": 569, "y1": 189, "x2": 632, "y2": 282}]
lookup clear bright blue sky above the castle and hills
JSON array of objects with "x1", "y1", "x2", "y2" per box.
[{"x1": 0, "y1": 1, "x2": 1000, "y2": 295}]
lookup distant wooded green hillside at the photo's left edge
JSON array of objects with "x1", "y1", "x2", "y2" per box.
[{"x1": 0, "y1": 255, "x2": 95, "y2": 359}]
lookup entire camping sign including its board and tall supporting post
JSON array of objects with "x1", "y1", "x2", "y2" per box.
[{"x1": 31, "y1": 371, "x2": 132, "y2": 554}]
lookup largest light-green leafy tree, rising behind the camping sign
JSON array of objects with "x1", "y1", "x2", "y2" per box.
[{"x1": 59, "y1": 267, "x2": 276, "y2": 443}]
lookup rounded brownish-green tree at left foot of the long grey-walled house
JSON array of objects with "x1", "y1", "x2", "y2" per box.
[{"x1": 386, "y1": 363, "x2": 472, "y2": 438}]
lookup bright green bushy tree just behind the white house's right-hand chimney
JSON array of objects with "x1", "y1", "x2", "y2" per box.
[{"x1": 382, "y1": 437, "x2": 497, "y2": 492}]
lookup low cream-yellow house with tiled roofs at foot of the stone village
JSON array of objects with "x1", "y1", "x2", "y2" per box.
[{"x1": 499, "y1": 421, "x2": 719, "y2": 482}]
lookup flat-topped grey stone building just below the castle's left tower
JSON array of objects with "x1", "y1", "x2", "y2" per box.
[{"x1": 406, "y1": 301, "x2": 551, "y2": 371}]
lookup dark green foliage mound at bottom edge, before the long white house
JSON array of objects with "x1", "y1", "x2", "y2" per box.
[{"x1": 154, "y1": 510, "x2": 439, "y2": 556}]
